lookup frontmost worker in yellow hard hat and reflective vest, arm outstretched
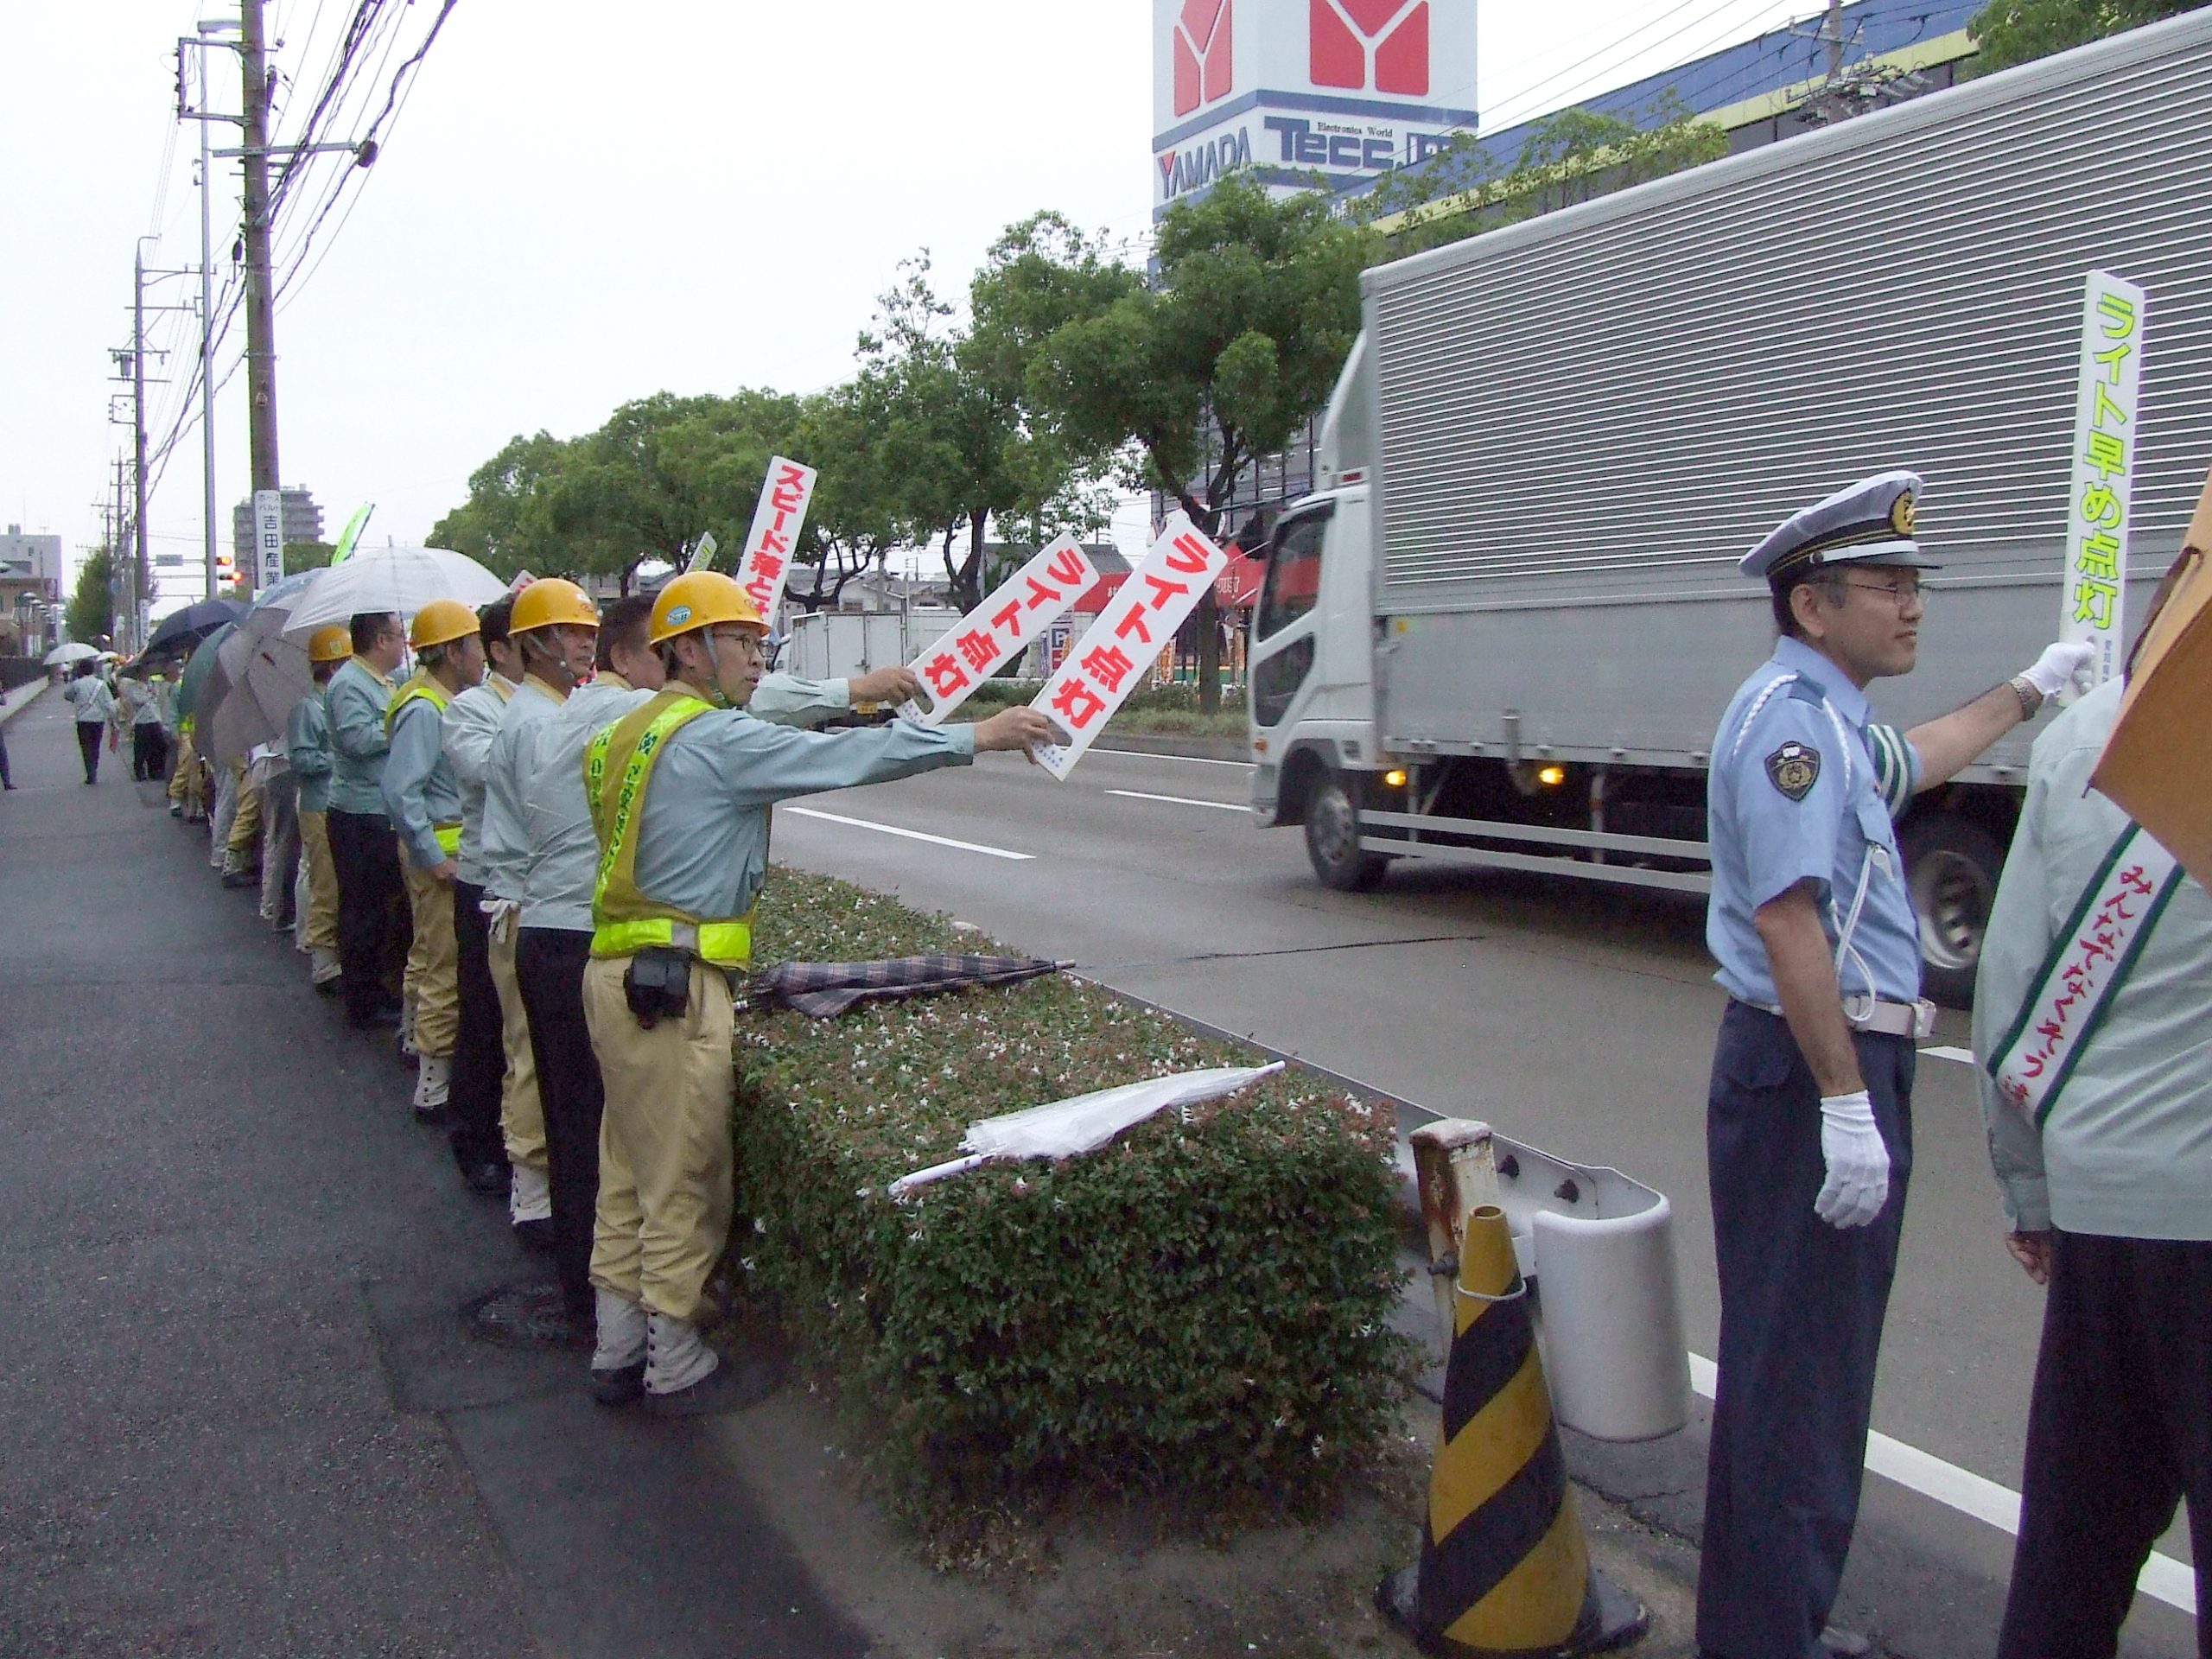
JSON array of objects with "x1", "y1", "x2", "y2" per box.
[{"x1": 584, "y1": 570, "x2": 1051, "y2": 1415}]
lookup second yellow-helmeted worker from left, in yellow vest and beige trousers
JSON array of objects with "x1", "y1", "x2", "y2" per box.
[{"x1": 385, "y1": 600, "x2": 485, "y2": 1117}]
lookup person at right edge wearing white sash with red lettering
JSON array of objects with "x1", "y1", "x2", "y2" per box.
[{"x1": 1974, "y1": 555, "x2": 2212, "y2": 1659}]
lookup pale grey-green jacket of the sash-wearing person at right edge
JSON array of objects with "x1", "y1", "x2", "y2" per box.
[{"x1": 1974, "y1": 679, "x2": 2212, "y2": 1239}]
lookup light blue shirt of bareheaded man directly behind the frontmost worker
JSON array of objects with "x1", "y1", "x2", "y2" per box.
[{"x1": 518, "y1": 671, "x2": 852, "y2": 933}]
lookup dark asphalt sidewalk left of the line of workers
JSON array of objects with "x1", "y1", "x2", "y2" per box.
[{"x1": 0, "y1": 696, "x2": 865, "y2": 1659}]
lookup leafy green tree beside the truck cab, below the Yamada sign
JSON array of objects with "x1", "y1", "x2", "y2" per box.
[{"x1": 1028, "y1": 175, "x2": 1376, "y2": 712}]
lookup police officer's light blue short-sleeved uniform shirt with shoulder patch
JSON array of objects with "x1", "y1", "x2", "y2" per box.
[{"x1": 1706, "y1": 639, "x2": 1920, "y2": 1008}]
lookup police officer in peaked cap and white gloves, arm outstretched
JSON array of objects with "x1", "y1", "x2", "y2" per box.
[{"x1": 1697, "y1": 471, "x2": 2088, "y2": 1659}]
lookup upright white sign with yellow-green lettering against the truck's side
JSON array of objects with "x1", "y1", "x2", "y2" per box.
[{"x1": 2059, "y1": 270, "x2": 2145, "y2": 702}]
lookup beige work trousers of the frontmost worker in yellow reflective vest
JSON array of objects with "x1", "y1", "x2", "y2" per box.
[{"x1": 584, "y1": 957, "x2": 736, "y2": 1323}]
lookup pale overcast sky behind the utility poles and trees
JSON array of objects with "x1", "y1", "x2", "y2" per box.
[{"x1": 0, "y1": 0, "x2": 1818, "y2": 611}]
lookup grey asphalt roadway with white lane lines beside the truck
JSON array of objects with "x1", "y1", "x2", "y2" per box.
[{"x1": 777, "y1": 752, "x2": 2195, "y2": 1655}]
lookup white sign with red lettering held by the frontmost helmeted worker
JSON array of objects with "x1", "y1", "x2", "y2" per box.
[{"x1": 1028, "y1": 513, "x2": 1230, "y2": 781}]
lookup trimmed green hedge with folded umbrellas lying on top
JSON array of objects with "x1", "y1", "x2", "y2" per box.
[{"x1": 734, "y1": 868, "x2": 1409, "y2": 1509}]
